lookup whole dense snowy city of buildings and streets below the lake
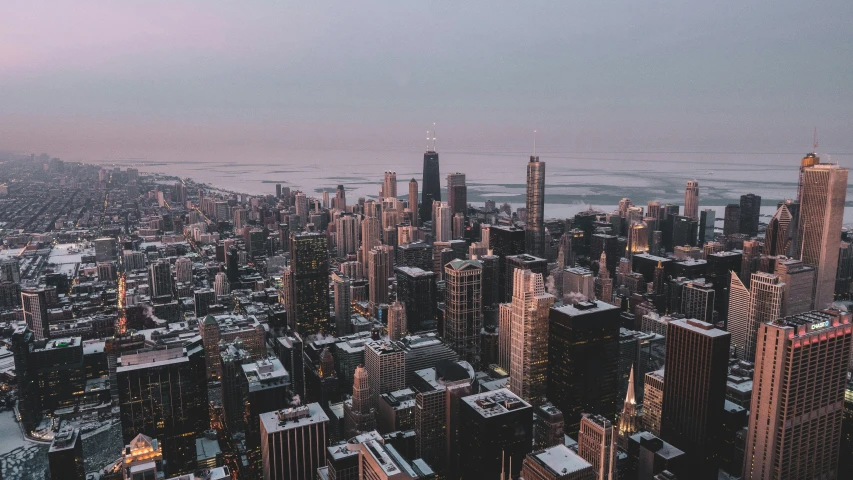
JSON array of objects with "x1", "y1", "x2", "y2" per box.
[{"x1": 0, "y1": 144, "x2": 853, "y2": 480}]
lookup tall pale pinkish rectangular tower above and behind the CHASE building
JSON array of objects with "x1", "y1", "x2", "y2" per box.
[{"x1": 799, "y1": 164, "x2": 848, "y2": 309}]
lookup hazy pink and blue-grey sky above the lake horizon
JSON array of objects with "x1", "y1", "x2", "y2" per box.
[{"x1": 0, "y1": 0, "x2": 853, "y2": 161}]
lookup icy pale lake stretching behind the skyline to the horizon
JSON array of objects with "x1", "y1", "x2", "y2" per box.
[{"x1": 86, "y1": 149, "x2": 853, "y2": 222}]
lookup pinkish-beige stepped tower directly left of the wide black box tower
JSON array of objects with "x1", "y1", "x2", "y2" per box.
[{"x1": 501, "y1": 269, "x2": 554, "y2": 406}]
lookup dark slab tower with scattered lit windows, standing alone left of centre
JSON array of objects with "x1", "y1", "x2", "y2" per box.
[{"x1": 288, "y1": 233, "x2": 329, "y2": 332}]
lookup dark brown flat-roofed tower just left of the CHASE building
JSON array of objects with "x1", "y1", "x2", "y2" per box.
[{"x1": 661, "y1": 319, "x2": 731, "y2": 479}]
